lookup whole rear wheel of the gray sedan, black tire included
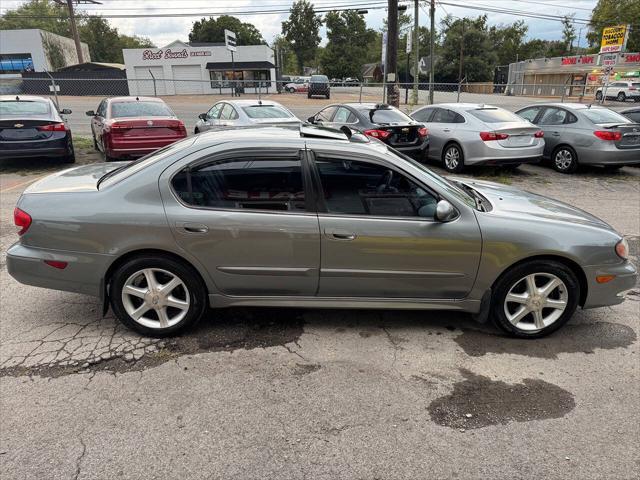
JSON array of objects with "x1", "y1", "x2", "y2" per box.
[{"x1": 109, "y1": 255, "x2": 207, "y2": 337}]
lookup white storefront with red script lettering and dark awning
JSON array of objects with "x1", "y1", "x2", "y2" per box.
[{"x1": 122, "y1": 41, "x2": 276, "y2": 95}]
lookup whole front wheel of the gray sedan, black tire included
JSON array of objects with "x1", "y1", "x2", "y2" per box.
[{"x1": 490, "y1": 260, "x2": 580, "y2": 338}]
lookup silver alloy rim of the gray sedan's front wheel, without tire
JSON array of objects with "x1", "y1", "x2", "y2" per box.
[{"x1": 504, "y1": 272, "x2": 569, "y2": 332}]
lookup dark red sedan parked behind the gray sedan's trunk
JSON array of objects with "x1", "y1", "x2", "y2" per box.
[{"x1": 86, "y1": 97, "x2": 187, "y2": 161}]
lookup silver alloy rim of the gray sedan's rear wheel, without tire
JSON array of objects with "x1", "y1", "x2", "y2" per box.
[{"x1": 122, "y1": 268, "x2": 191, "y2": 329}]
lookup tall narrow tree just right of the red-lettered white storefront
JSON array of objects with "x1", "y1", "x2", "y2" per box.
[{"x1": 282, "y1": 0, "x2": 322, "y2": 72}]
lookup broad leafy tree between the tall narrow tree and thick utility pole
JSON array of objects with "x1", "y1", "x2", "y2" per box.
[{"x1": 320, "y1": 10, "x2": 376, "y2": 78}]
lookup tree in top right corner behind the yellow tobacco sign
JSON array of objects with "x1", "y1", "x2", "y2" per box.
[{"x1": 587, "y1": 0, "x2": 640, "y2": 52}]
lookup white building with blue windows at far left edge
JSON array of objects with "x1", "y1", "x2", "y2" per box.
[{"x1": 0, "y1": 28, "x2": 91, "y2": 78}]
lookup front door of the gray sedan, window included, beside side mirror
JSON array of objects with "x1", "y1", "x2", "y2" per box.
[{"x1": 312, "y1": 149, "x2": 481, "y2": 299}]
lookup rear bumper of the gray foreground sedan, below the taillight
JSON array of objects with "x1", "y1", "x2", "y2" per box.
[{"x1": 7, "y1": 243, "x2": 113, "y2": 297}]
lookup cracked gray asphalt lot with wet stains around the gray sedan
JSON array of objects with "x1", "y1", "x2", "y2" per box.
[{"x1": 0, "y1": 115, "x2": 640, "y2": 480}]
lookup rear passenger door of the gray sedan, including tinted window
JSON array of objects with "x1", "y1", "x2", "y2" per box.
[{"x1": 160, "y1": 146, "x2": 320, "y2": 296}]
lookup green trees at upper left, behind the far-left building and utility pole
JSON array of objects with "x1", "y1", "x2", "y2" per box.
[{"x1": 0, "y1": 0, "x2": 153, "y2": 63}]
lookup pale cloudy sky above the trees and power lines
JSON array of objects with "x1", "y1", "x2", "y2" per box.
[{"x1": 0, "y1": 0, "x2": 597, "y2": 47}]
